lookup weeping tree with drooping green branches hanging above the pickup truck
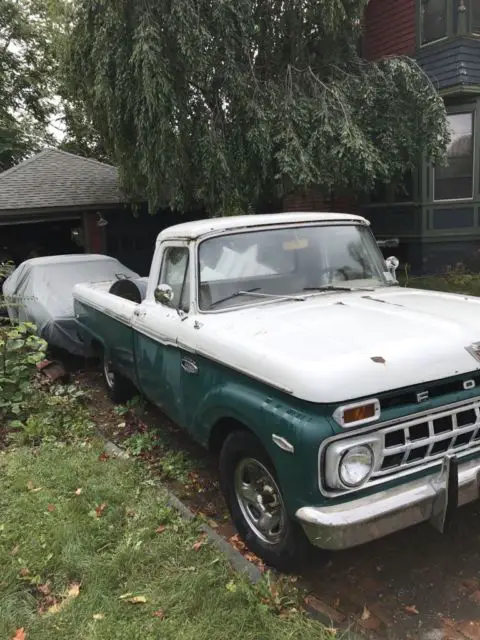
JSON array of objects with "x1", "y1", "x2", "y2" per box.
[{"x1": 67, "y1": 0, "x2": 448, "y2": 214}]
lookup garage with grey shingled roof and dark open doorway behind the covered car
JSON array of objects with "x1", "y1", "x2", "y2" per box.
[{"x1": 0, "y1": 149, "x2": 125, "y2": 265}]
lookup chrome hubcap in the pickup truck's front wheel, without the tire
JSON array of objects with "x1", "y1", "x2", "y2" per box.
[{"x1": 235, "y1": 458, "x2": 287, "y2": 544}]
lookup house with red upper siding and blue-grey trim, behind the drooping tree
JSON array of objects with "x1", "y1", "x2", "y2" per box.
[{"x1": 362, "y1": 0, "x2": 480, "y2": 272}]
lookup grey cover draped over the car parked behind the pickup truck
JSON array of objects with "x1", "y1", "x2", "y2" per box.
[{"x1": 3, "y1": 254, "x2": 139, "y2": 355}]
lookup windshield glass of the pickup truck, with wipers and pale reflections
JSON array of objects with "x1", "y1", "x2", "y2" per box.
[{"x1": 199, "y1": 225, "x2": 392, "y2": 311}]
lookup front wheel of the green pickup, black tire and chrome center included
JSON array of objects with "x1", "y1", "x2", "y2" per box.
[{"x1": 220, "y1": 431, "x2": 313, "y2": 572}]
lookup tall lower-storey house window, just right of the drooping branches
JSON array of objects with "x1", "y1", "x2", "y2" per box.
[{"x1": 434, "y1": 113, "x2": 473, "y2": 200}]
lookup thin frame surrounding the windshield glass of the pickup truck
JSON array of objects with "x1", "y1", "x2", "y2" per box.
[{"x1": 192, "y1": 219, "x2": 397, "y2": 315}]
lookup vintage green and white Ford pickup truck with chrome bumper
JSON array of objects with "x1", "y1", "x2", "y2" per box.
[{"x1": 74, "y1": 213, "x2": 480, "y2": 569}]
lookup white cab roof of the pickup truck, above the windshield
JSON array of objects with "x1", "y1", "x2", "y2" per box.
[{"x1": 157, "y1": 212, "x2": 369, "y2": 242}]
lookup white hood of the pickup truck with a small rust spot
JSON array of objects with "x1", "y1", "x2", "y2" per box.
[{"x1": 192, "y1": 287, "x2": 480, "y2": 403}]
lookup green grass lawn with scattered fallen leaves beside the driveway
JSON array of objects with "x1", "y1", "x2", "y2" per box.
[{"x1": 0, "y1": 444, "x2": 328, "y2": 640}]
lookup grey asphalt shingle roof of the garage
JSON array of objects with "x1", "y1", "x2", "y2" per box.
[{"x1": 0, "y1": 149, "x2": 125, "y2": 215}]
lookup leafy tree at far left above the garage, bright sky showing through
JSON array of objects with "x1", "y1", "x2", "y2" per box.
[{"x1": 0, "y1": 0, "x2": 57, "y2": 171}]
